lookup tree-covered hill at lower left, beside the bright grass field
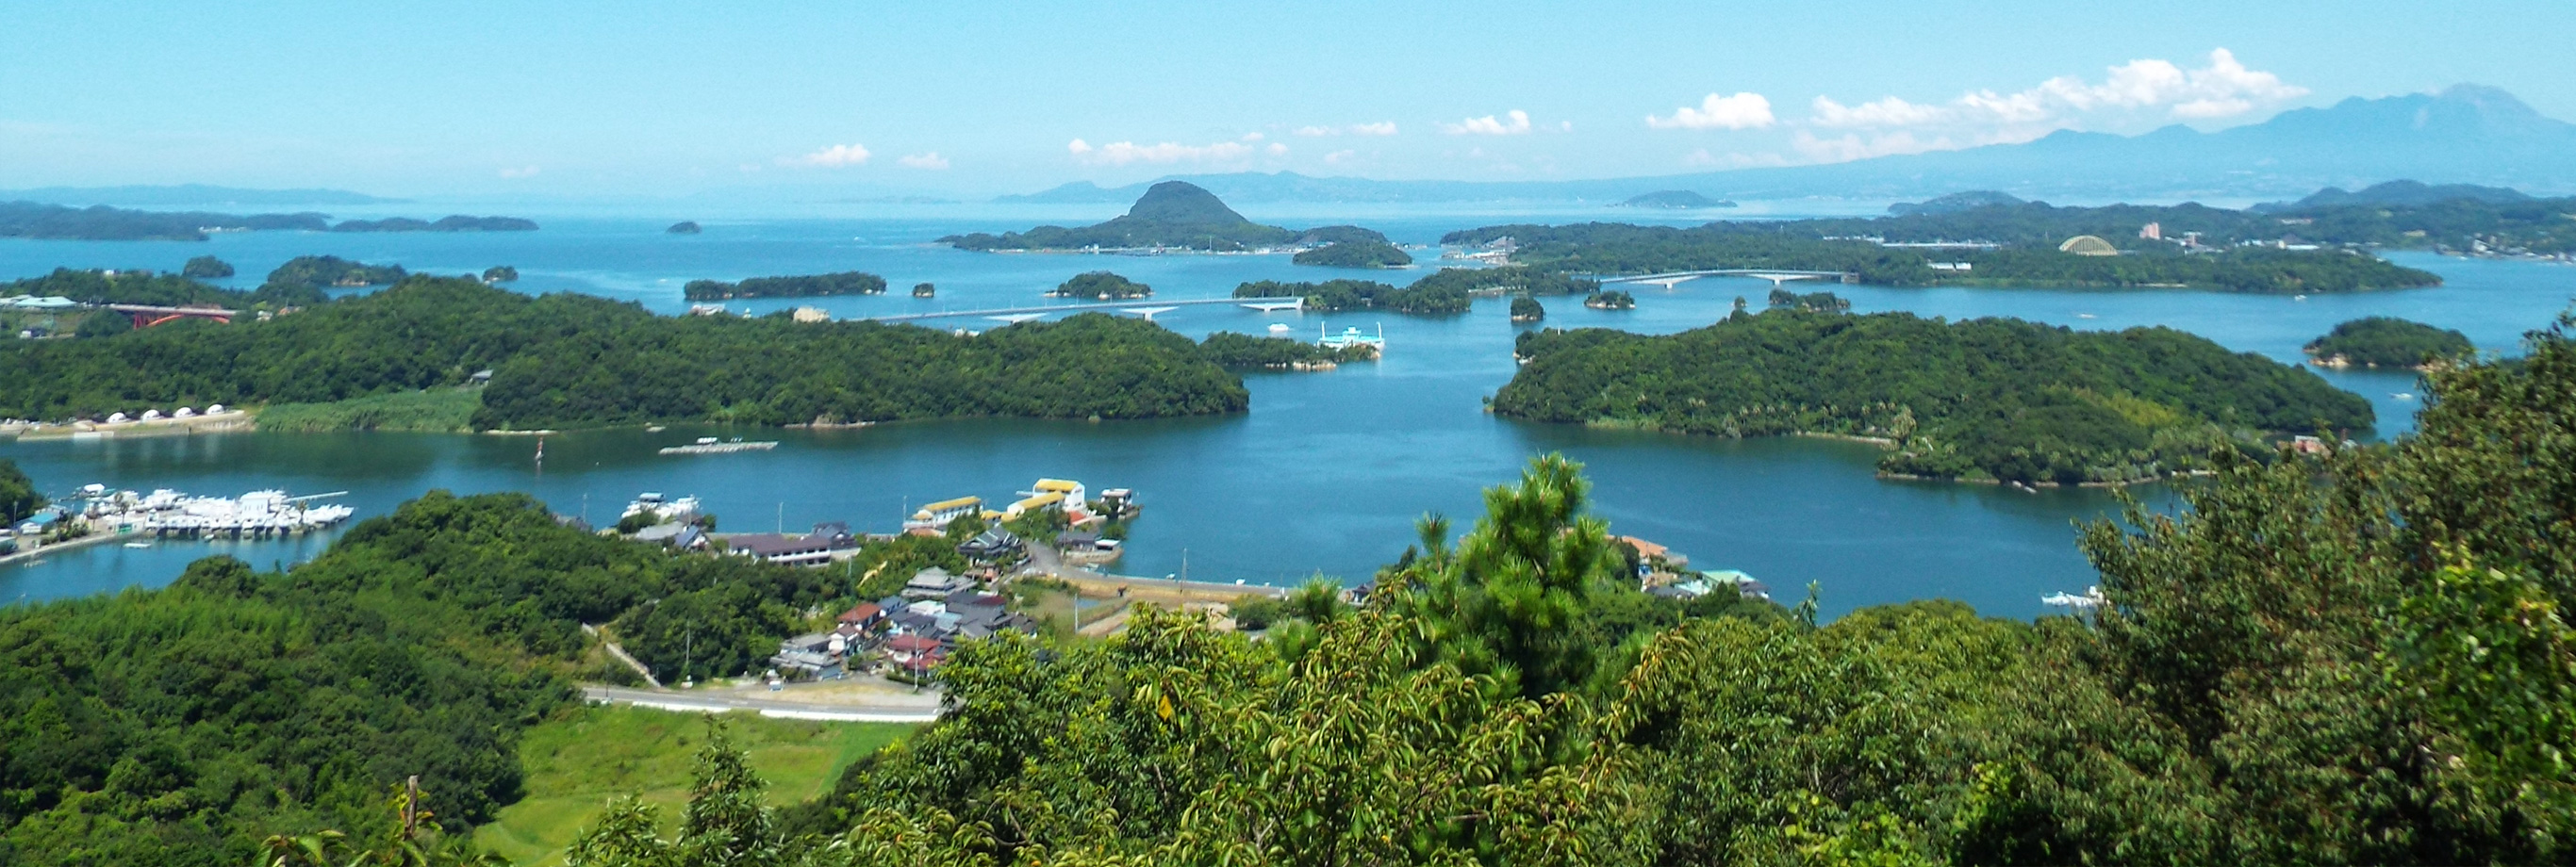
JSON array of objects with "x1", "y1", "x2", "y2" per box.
[{"x1": 0, "y1": 491, "x2": 848, "y2": 867}]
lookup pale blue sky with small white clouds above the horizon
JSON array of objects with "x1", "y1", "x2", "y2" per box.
[{"x1": 0, "y1": 0, "x2": 2576, "y2": 195}]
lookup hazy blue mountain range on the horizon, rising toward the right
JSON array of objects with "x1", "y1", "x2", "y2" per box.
[{"x1": 997, "y1": 85, "x2": 2576, "y2": 205}]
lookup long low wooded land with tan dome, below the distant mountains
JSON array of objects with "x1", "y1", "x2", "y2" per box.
[{"x1": 1443, "y1": 220, "x2": 2442, "y2": 293}]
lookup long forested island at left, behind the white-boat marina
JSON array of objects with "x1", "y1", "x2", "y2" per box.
[{"x1": 0, "y1": 275, "x2": 1247, "y2": 430}]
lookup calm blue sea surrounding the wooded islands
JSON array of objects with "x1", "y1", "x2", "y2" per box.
[{"x1": 0, "y1": 205, "x2": 2576, "y2": 617}]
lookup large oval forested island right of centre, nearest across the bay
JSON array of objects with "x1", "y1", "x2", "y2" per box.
[{"x1": 1494, "y1": 306, "x2": 2372, "y2": 483}]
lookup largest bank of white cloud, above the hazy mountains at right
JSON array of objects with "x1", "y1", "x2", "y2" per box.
[{"x1": 1798, "y1": 49, "x2": 2308, "y2": 146}]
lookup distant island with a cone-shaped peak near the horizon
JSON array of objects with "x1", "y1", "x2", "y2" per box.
[{"x1": 940, "y1": 180, "x2": 1386, "y2": 253}]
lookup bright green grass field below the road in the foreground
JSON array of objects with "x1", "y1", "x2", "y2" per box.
[{"x1": 474, "y1": 708, "x2": 915, "y2": 864}]
